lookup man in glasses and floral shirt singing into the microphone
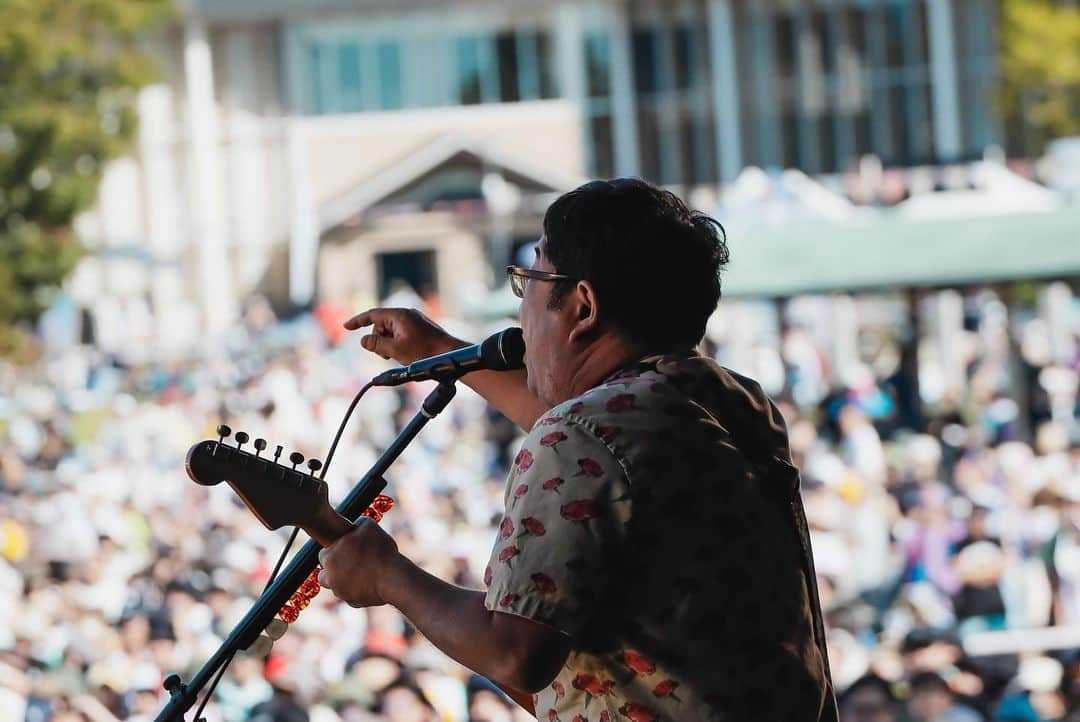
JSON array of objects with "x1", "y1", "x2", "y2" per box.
[{"x1": 320, "y1": 179, "x2": 836, "y2": 722}]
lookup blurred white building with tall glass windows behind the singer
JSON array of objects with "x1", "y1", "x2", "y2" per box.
[{"x1": 72, "y1": 0, "x2": 998, "y2": 347}]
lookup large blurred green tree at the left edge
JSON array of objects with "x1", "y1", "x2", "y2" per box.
[{"x1": 0, "y1": 0, "x2": 172, "y2": 346}]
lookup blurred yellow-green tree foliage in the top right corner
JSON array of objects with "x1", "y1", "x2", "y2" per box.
[{"x1": 999, "y1": 0, "x2": 1080, "y2": 153}]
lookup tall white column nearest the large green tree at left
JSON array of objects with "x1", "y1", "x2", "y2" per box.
[{"x1": 184, "y1": 17, "x2": 237, "y2": 330}]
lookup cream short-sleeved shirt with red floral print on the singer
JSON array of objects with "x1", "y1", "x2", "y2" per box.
[{"x1": 484, "y1": 354, "x2": 836, "y2": 722}]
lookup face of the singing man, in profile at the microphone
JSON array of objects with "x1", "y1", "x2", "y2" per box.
[{"x1": 518, "y1": 237, "x2": 570, "y2": 406}]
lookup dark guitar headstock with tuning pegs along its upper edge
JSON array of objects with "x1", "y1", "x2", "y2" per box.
[{"x1": 186, "y1": 426, "x2": 348, "y2": 539}]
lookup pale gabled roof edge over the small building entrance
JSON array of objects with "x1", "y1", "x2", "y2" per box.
[{"x1": 319, "y1": 134, "x2": 588, "y2": 233}]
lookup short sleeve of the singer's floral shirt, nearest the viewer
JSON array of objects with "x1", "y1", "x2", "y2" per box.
[{"x1": 484, "y1": 416, "x2": 632, "y2": 636}]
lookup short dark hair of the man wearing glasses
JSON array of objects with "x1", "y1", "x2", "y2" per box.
[{"x1": 543, "y1": 178, "x2": 730, "y2": 353}]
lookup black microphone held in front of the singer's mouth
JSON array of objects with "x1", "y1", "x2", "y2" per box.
[{"x1": 372, "y1": 327, "x2": 525, "y2": 386}]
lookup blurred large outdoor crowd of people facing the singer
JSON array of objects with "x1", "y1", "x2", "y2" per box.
[{"x1": 0, "y1": 289, "x2": 1080, "y2": 722}]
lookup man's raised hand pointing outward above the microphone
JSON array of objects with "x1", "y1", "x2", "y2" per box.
[{"x1": 345, "y1": 309, "x2": 469, "y2": 366}]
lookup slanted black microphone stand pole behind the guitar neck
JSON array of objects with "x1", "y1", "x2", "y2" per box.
[{"x1": 154, "y1": 376, "x2": 457, "y2": 722}]
